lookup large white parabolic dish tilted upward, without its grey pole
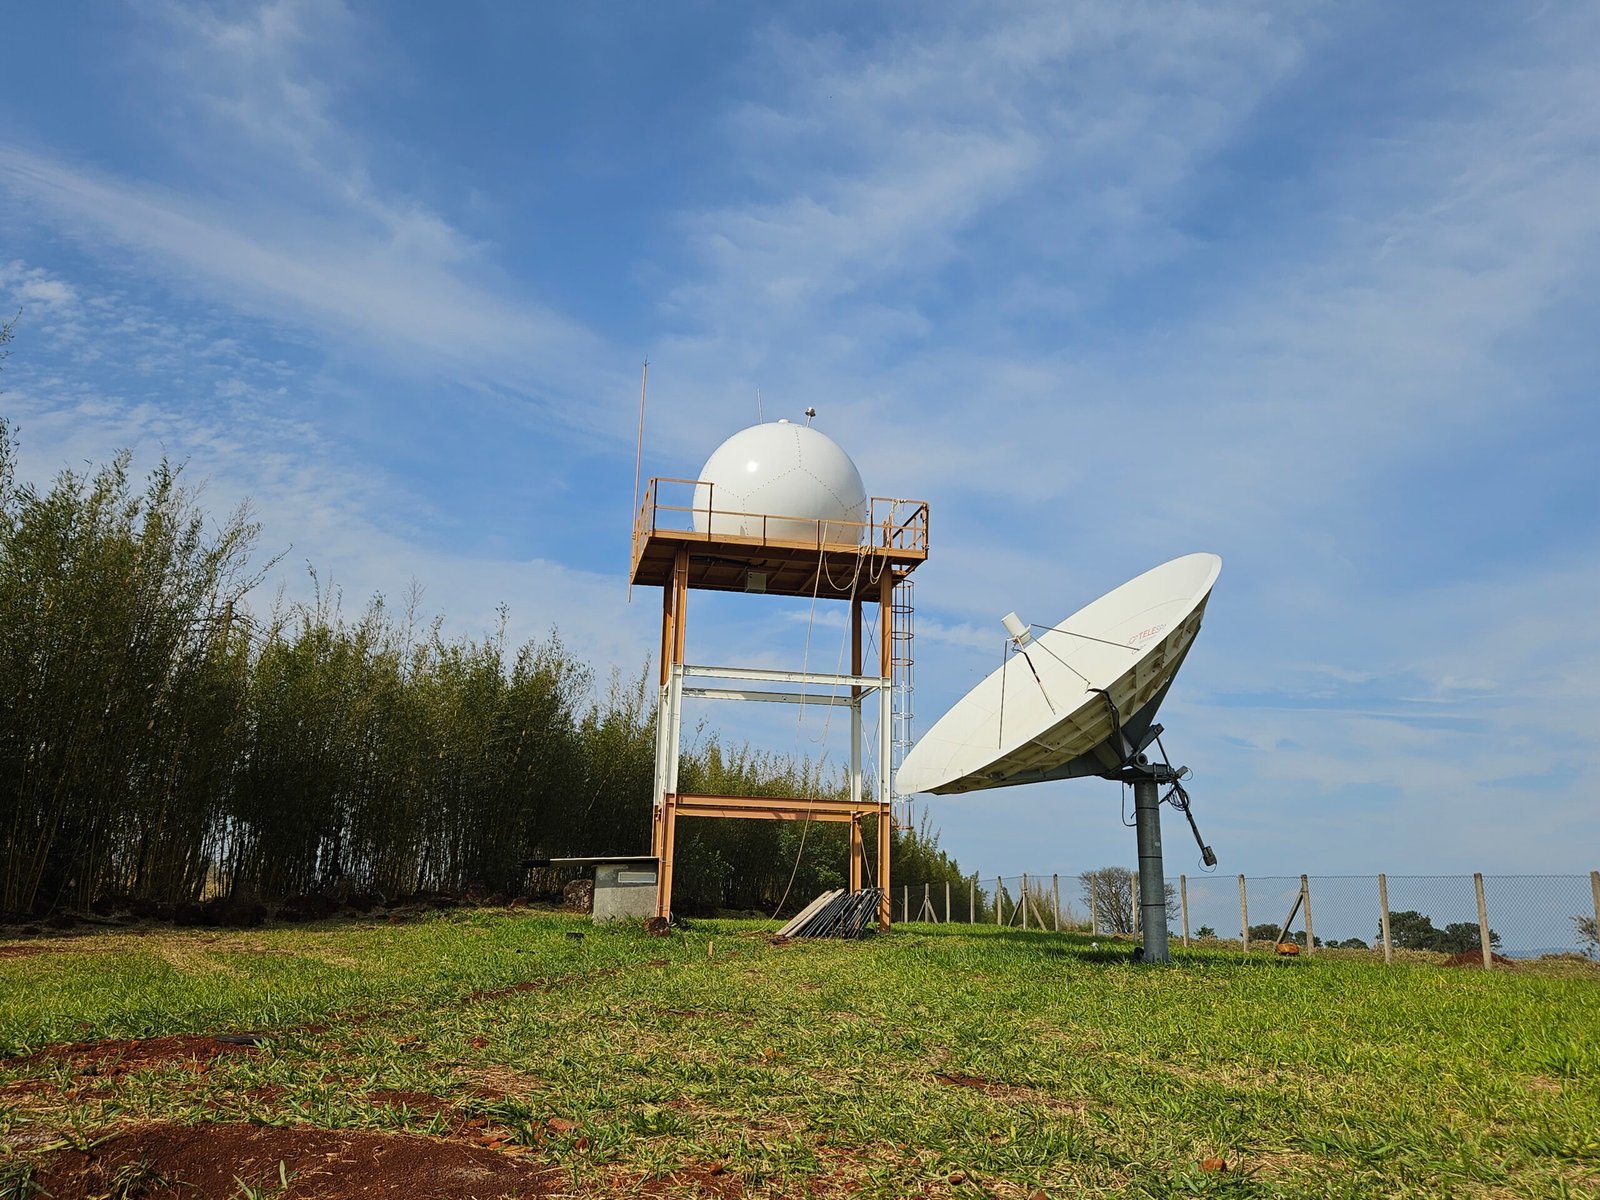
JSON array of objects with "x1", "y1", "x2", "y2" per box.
[{"x1": 894, "y1": 554, "x2": 1222, "y2": 795}]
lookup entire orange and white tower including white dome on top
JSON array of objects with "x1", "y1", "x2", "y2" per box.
[{"x1": 629, "y1": 411, "x2": 928, "y2": 928}]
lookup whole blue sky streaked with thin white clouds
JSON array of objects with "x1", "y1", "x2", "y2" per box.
[{"x1": 0, "y1": 0, "x2": 1600, "y2": 875}]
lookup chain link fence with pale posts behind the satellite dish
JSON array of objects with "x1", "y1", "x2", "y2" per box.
[{"x1": 891, "y1": 867, "x2": 1600, "y2": 960}]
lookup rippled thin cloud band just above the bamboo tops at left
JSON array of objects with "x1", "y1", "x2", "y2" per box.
[{"x1": 0, "y1": 264, "x2": 656, "y2": 683}]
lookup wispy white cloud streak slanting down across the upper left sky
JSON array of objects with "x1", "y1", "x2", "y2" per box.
[{"x1": 0, "y1": 0, "x2": 629, "y2": 430}]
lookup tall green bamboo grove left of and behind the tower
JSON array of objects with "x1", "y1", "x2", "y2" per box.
[{"x1": 0, "y1": 421, "x2": 965, "y2": 914}]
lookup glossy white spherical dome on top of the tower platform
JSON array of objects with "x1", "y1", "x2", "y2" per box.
[{"x1": 694, "y1": 421, "x2": 867, "y2": 544}]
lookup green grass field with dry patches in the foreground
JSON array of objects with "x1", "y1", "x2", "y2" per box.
[{"x1": 0, "y1": 910, "x2": 1600, "y2": 1200}]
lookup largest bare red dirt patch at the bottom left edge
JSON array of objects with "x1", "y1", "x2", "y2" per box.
[{"x1": 29, "y1": 1125, "x2": 566, "y2": 1200}]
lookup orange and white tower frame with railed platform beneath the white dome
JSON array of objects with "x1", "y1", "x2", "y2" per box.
[{"x1": 629, "y1": 478, "x2": 928, "y2": 930}]
